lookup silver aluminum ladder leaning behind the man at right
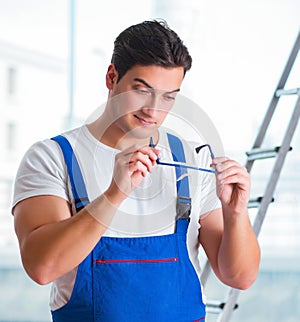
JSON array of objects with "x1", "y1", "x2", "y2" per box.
[{"x1": 201, "y1": 30, "x2": 300, "y2": 322}]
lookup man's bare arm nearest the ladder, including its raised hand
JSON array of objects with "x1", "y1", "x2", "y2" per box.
[{"x1": 199, "y1": 158, "x2": 260, "y2": 289}]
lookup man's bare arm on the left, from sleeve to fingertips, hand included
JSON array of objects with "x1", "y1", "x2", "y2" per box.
[{"x1": 14, "y1": 147, "x2": 158, "y2": 284}]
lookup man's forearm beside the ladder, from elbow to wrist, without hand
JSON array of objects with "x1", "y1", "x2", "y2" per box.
[{"x1": 218, "y1": 209, "x2": 260, "y2": 289}]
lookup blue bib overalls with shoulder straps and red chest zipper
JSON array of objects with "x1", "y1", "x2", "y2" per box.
[{"x1": 52, "y1": 134, "x2": 205, "y2": 322}]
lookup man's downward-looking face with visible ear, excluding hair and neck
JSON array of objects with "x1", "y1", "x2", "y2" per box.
[{"x1": 106, "y1": 65, "x2": 184, "y2": 139}]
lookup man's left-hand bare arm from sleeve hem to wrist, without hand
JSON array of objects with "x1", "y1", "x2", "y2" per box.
[{"x1": 14, "y1": 196, "x2": 115, "y2": 284}]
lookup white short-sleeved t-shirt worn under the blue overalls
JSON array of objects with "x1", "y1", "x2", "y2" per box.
[{"x1": 13, "y1": 126, "x2": 220, "y2": 310}]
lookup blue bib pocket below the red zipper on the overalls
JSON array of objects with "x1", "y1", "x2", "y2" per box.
[{"x1": 94, "y1": 259, "x2": 178, "y2": 321}]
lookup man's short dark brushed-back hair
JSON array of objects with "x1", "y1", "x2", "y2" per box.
[{"x1": 111, "y1": 20, "x2": 192, "y2": 81}]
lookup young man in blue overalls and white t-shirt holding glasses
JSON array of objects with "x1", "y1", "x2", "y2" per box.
[{"x1": 13, "y1": 21, "x2": 260, "y2": 322}]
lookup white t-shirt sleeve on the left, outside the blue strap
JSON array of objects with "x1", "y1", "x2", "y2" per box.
[{"x1": 12, "y1": 140, "x2": 70, "y2": 212}]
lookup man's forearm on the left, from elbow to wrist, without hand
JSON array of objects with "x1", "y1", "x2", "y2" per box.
[{"x1": 20, "y1": 192, "x2": 117, "y2": 284}]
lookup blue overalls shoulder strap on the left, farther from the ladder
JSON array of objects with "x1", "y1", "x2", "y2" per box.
[{"x1": 51, "y1": 135, "x2": 89, "y2": 212}]
